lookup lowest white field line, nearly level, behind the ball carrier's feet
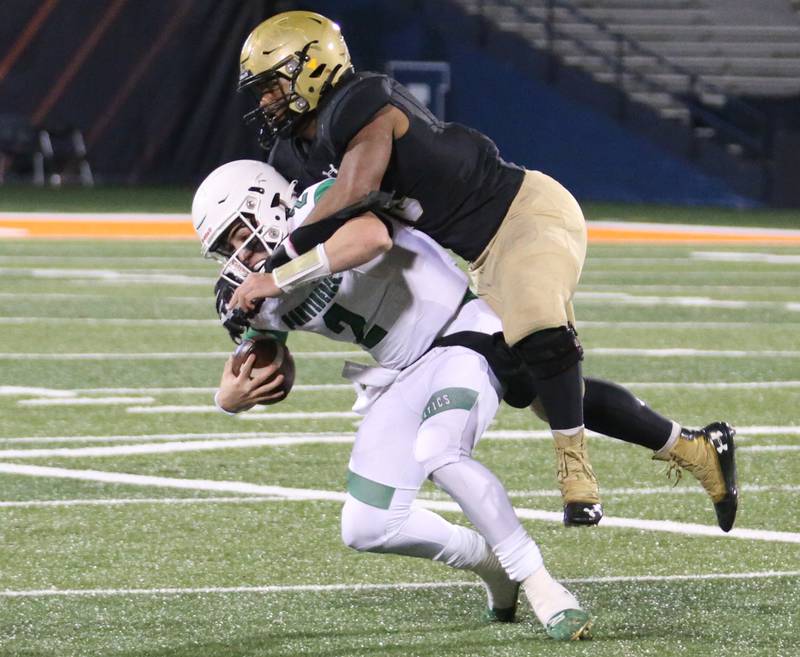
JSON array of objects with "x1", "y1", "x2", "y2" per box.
[{"x1": 0, "y1": 570, "x2": 800, "y2": 598}]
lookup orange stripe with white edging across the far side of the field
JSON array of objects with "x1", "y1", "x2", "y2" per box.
[{"x1": 0, "y1": 213, "x2": 800, "y2": 245}]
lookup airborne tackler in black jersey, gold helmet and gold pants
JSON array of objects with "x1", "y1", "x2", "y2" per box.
[{"x1": 230, "y1": 11, "x2": 738, "y2": 531}]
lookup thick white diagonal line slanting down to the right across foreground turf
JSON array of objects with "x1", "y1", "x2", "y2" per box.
[{"x1": 0, "y1": 463, "x2": 800, "y2": 544}]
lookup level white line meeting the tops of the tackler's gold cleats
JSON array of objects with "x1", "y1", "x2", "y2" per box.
[{"x1": 0, "y1": 426, "x2": 800, "y2": 446}]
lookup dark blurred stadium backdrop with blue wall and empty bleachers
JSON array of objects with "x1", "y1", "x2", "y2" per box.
[{"x1": 0, "y1": 0, "x2": 800, "y2": 207}]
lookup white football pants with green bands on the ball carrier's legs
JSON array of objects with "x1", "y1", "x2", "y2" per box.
[{"x1": 342, "y1": 347, "x2": 542, "y2": 581}]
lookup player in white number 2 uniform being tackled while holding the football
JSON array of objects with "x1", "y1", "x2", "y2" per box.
[{"x1": 192, "y1": 160, "x2": 591, "y2": 640}]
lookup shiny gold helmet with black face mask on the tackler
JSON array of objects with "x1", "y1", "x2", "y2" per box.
[{"x1": 239, "y1": 11, "x2": 352, "y2": 148}]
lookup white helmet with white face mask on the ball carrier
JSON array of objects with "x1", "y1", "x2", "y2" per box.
[{"x1": 192, "y1": 160, "x2": 295, "y2": 278}]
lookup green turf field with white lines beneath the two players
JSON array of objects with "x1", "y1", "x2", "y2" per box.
[{"x1": 0, "y1": 233, "x2": 800, "y2": 657}]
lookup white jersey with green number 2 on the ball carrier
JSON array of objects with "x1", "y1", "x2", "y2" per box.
[{"x1": 251, "y1": 181, "x2": 501, "y2": 370}]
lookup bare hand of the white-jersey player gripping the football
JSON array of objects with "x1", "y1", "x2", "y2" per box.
[{"x1": 217, "y1": 354, "x2": 286, "y2": 413}]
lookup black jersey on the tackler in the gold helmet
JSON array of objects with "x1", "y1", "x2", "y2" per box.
[{"x1": 269, "y1": 73, "x2": 524, "y2": 260}]
